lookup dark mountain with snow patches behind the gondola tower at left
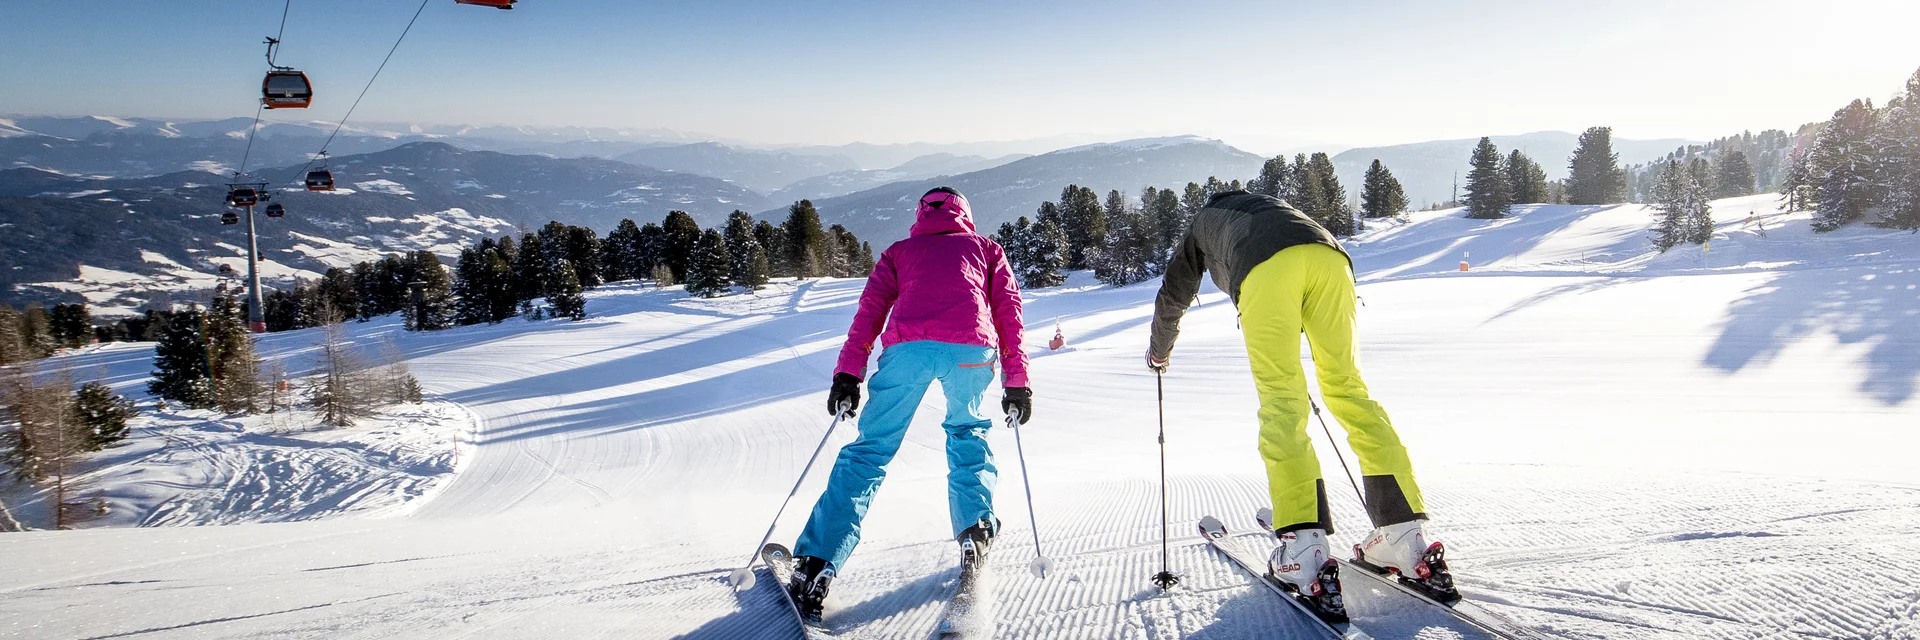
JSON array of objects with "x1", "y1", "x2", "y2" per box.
[{"x1": 0, "y1": 142, "x2": 770, "y2": 315}]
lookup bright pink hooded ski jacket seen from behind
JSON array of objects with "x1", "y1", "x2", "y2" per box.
[{"x1": 833, "y1": 192, "x2": 1027, "y2": 386}]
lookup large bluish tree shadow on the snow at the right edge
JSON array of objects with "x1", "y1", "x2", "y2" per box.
[{"x1": 1705, "y1": 263, "x2": 1920, "y2": 406}]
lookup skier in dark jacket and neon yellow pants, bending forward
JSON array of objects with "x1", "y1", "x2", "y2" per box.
[{"x1": 1146, "y1": 190, "x2": 1459, "y2": 621}]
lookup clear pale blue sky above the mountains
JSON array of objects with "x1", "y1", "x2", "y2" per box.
[{"x1": 0, "y1": 0, "x2": 1920, "y2": 150}]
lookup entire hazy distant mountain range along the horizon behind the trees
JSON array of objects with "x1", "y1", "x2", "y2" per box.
[{"x1": 0, "y1": 117, "x2": 1712, "y2": 311}]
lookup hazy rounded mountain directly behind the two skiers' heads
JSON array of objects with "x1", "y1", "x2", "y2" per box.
[{"x1": 787, "y1": 136, "x2": 1263, "y2": 242}]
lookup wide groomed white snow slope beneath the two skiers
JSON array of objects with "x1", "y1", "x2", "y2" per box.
[{"x1": 0, "y1": 198, "x2": 1920, "y2": 638}]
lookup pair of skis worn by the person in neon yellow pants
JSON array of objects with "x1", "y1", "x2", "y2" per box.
[{"x1": 1200, "y1": 509, "x2": 1536, "y2": 640}]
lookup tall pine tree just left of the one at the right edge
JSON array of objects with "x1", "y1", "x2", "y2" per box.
[{"x1": 1812, "y1": 100, "x2": 1878, "y2": 231}]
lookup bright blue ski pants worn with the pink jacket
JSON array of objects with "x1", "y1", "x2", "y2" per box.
[{"x1": 793, "y1": 340, "x2": 998, "y2": 567}]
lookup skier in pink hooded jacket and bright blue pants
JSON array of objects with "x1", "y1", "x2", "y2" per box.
[{"x1": 787, "y1": 186, "x2": 1033, "y2": 619}]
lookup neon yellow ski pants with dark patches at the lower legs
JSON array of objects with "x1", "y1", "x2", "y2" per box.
[{"x1": 1240, "y1": 244, "x2": 1427, "y2": 532}]
